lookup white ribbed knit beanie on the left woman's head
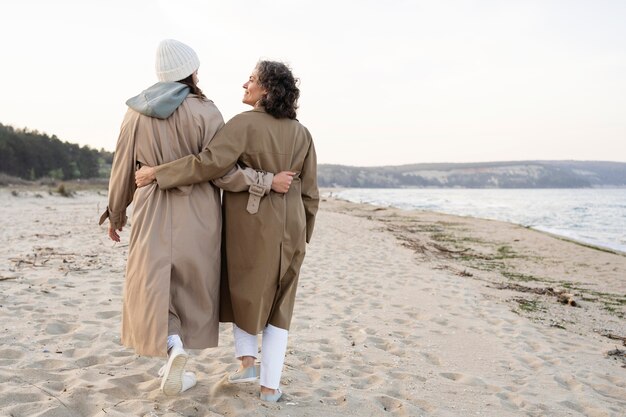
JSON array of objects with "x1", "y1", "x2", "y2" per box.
[{"x1": 155, "y1": 39, "x2": 200, "y2": 81}]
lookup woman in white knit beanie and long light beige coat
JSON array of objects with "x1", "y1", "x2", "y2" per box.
[{"x1": 100, "y1": 39, "x2": 288, "y2": 395}]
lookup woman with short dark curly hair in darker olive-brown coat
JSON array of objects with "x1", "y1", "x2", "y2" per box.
[{"x1": 135, "y1": 61, "x2": 319, "y2": 402}]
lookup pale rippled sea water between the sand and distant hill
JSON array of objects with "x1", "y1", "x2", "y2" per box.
[{"x1": 332, "y1": 188, "x2": 626, "y2": 252}]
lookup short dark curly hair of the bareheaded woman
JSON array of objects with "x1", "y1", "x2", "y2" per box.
[{"x1": 256, "y1": 61, "x2": 300, "y2": 119}]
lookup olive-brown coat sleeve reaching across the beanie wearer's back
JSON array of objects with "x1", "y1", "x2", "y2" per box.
[{"x1": 155, "y1": 119, "x2": 246, "y2": 190}]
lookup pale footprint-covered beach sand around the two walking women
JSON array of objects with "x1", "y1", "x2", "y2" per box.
[{"x1": 0, "y1": 188, "x2": 626, "y2": 417}]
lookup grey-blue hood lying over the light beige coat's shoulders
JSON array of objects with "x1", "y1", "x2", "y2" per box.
[{"x1": 126, "y1": 82, "x2": 190, "y2": 119}]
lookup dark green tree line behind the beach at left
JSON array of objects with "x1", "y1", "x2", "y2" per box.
[{"x1": 0, "y1": 123, "x2": 113, "y2": 181}]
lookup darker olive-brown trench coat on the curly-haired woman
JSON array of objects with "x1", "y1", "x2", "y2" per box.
[{"x1": 156, "y1": 109, "x2": 319, "y2": 334}]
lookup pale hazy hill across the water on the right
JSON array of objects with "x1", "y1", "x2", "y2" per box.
[{"x1": 318, "y1": 161, "x2": 626, "y2": 188}]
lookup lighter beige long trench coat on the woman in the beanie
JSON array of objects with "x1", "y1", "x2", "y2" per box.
[{"x1": 100, "y1": 94, "x2": 271, "y2": 356}]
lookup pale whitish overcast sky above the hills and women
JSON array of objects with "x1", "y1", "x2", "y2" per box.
[{"x1": 0, "y1": 0, "x2": 626, "y2": 166}]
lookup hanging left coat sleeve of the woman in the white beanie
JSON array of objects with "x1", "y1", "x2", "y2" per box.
[{"x1": 99, "y1": 110, "x2": 137, "y2": 229}]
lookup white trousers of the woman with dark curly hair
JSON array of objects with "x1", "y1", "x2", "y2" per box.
[{"x1": 233, "y1": 323, "x2": 289, "y2": 389}]
